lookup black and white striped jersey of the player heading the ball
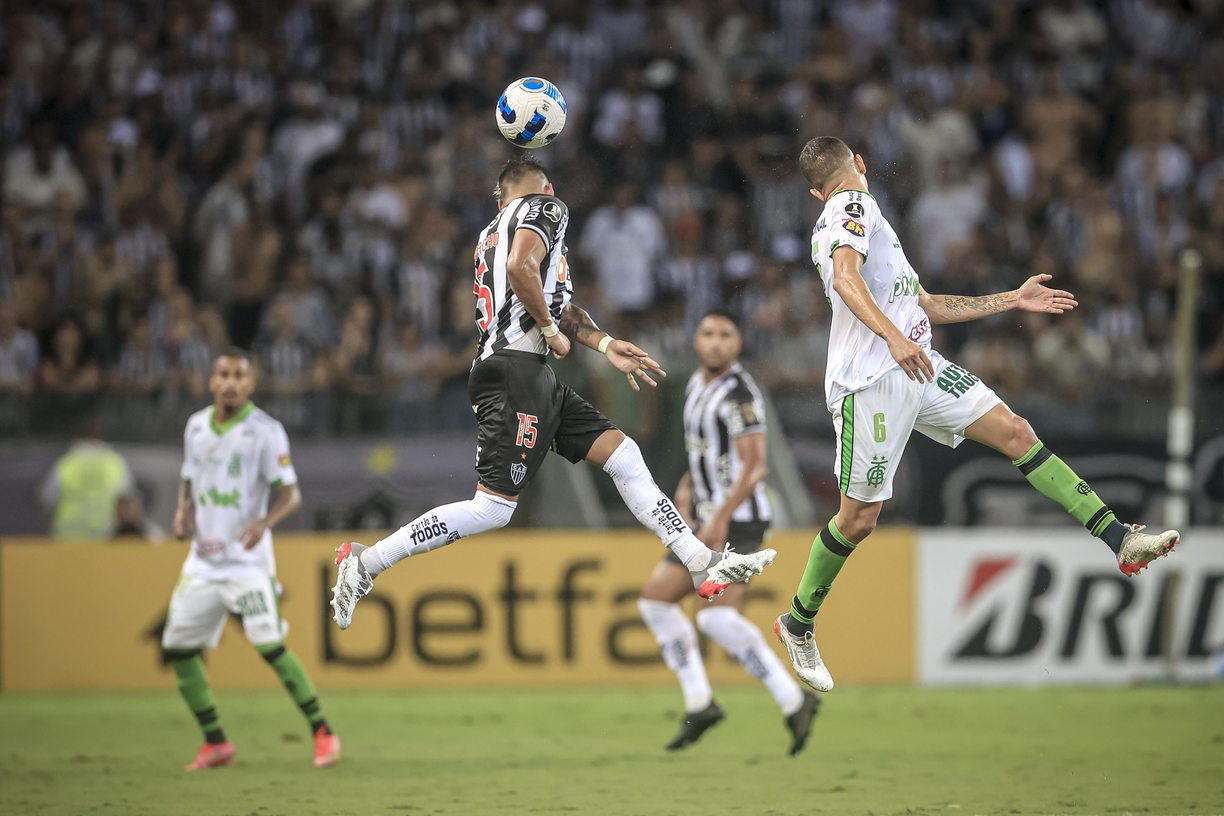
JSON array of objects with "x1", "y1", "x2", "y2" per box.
[{"x1": 471, "y1": 193, "x2": 574, "y2": 361}]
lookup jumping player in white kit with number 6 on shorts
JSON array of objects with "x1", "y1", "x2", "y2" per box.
[{"x1": 774, "y1": 137, "x2": 1180, "y2": 691}]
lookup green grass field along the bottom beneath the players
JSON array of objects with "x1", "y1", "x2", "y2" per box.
[{"x1": 0, "y1": 688, "x2": 1224, "y2": 816}]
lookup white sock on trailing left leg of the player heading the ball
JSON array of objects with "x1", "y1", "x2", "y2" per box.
[{"x1": 361, "y1": 491, "x2": 517, "y2": 575}]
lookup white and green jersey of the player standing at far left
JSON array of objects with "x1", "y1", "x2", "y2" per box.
[{"x1": 181, "y1": 402, "x2": 297, "y2": 580}]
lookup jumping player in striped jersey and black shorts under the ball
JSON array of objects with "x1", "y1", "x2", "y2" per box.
[{"x1": 332, "y1": 155, "x2": 776, "y2": 629}]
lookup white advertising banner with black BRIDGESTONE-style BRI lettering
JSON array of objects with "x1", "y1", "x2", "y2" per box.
[{"x1": 916, "y1": 529, "x2": 1224, "y2": 685}]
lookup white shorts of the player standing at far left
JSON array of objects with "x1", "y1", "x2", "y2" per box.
[{"x1": 162, "y1": 574, "x2": 289, "y2": 648}]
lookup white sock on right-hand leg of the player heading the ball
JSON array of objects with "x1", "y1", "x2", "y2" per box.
[{"x1": 603, "y1": 437, "x2": 717, "y2": 573}]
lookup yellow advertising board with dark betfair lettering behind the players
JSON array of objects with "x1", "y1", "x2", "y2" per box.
[{"x1": 0, "y1": 530, "x2": 914, "y2": 691}]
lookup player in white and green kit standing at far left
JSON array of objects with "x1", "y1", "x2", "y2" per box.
[{"x1": 162, "y1": 349, "x2": 340, "y2": 771}]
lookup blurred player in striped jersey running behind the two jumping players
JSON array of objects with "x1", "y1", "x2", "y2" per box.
[{"x1": 638, "y1": 311, "x2": 820, "y2": 756}]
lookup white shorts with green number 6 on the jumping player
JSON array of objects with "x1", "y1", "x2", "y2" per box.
[{"x1": 830, "y1": 350, "x2": 1002, "y2": 502}]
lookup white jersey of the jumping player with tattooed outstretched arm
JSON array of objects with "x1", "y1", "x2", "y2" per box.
[{"x1": 812, "y1": 190, "x2": 930, "y2": 406}]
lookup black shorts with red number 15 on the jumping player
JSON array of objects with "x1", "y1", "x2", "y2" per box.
[{"x1": 468, "y1": 349, "x2": 616, "y2": 495}]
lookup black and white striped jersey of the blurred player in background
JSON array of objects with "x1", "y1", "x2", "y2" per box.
[{"x1": 684, "y1": 362, "x2": 774, "y2": 522}]
